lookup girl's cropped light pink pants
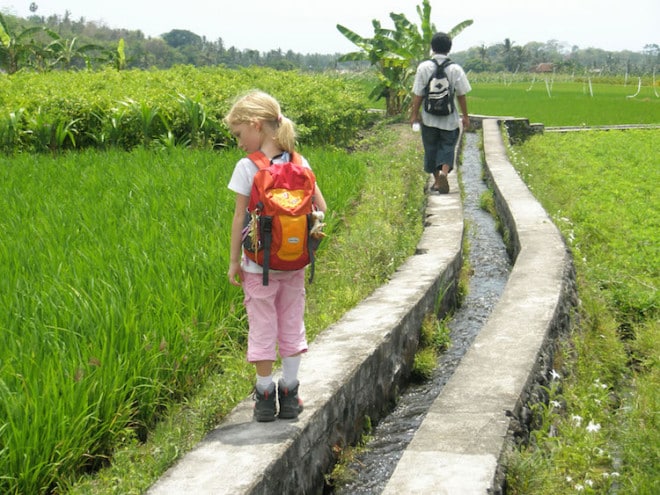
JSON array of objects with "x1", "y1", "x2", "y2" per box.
[{"x1": 243, "y1": 270, "x2": 307, "y2": 363}]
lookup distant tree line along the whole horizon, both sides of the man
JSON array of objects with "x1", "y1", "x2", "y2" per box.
[{"x1": 0, "y1": 7, "x2": 660, "y2": 75}]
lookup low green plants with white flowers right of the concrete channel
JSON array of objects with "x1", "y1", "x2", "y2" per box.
[{"x1": 508, "y1": 130, "x2": 660, "y2": 494}]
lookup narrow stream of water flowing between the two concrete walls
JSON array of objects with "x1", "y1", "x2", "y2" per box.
[{"x1": 336, "y1": 133, "x2": 511, "y2": 495}]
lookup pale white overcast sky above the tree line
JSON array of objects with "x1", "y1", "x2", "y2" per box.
[{"x1": 0, "y1": 0, "x2": 660, "y2": 54}]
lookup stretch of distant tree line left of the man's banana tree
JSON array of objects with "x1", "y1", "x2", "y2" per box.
[{"x1": 0, "y1": 9, "x2": 346, "y2": 74}]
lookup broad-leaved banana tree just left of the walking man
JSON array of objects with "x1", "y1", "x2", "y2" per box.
[{"x1": 337, "y1": 0, "x2": 473, "y2": 116}]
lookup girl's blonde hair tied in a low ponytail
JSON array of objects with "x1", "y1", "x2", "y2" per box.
[{"x1": 224, "y1": 90, "x2": 296, "y2": 153}]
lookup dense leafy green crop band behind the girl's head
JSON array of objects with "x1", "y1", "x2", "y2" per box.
[{"x1": 0, "y1": 66, "x2": 375, "y2": 153}]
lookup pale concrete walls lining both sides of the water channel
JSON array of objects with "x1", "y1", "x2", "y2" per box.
[{"x1": 148, "y1": 120, "x2": 575, "y2": 495}]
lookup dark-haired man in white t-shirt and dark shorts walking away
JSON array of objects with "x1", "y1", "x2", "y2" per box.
[{"x1": 410, "y1": 33, "x2": 472, "y2": 194}]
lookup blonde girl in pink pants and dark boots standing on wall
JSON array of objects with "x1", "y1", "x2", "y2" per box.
[{"x1": 225, "y1": 91, "x2": 326, "y2": 421}]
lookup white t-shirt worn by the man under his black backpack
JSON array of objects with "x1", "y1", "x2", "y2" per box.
[{"x1": 413, "y1": 54, "x2": 472, "y2": 131}]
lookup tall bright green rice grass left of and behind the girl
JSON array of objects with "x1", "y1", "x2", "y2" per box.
[{"x1": 0, "y1": 148, "x2": 372, "y2": 493}]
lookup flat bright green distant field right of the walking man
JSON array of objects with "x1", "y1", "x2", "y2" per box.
[{"x1": 468, "y1": 78, "x2": 660, "y2": 126}]
